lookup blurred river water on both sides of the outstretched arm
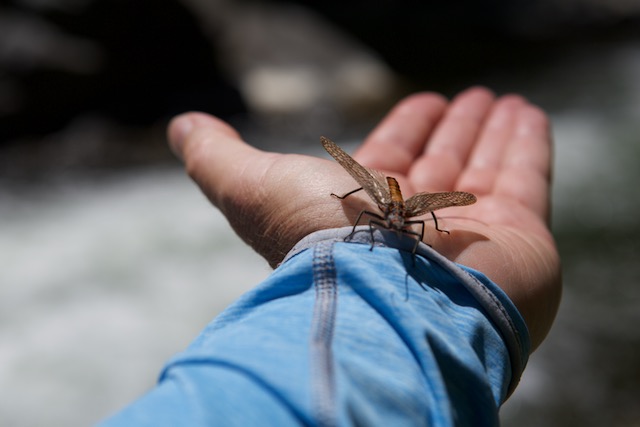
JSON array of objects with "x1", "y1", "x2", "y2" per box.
[{"x1": 0, "y1": 41, "x2": 640, "y2": 427}]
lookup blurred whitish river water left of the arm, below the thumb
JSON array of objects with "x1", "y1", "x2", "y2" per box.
[{"x1": 0, "y1": 169, "x2": 269, "y2": 426}]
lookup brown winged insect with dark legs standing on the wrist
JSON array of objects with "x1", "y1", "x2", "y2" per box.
[{"x1": 320, "y1": 136, "x2": 476, "y2": 253}]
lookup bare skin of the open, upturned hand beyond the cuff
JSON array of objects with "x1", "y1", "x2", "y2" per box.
[{"x1": 168, "y1": 87, "x2": 561, "y2": 348}]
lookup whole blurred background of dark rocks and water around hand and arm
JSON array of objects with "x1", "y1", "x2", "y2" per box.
[{"x1": 0, "y1": 0, "x2": 640, "y2": 426}]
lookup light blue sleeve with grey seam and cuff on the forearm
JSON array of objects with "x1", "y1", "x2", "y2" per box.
[{"x1": 102, "y1": 233, "x2": 529, "y2": 426}]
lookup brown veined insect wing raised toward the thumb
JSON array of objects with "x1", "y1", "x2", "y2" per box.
[{"x1": 320, "y1": 136, "x2": 391, "y2": 206}]
